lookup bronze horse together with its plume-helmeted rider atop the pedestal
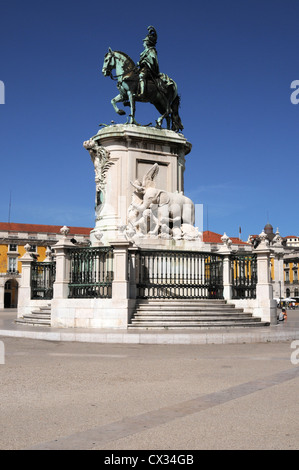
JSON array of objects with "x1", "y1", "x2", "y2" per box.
[{"x1": 102, "y1": 26, "x2": 183, "y2": 132}]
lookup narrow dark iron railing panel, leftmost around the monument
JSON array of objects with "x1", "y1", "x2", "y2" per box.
[{"x1": 31, "y1": 261, "x2": 56, "y2": 300}]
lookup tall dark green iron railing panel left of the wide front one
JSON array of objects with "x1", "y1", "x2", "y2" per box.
[{"x1": 69, "y1": 247, "x2": 113, "y2": 299}]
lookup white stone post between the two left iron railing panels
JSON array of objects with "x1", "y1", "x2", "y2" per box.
[{"x1": 53, "y1": 226, "x2": 74, "y2": 299}]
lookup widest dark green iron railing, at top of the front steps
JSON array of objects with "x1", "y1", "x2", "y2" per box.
[{"x1": 136, "y1": 250, "x2": 223, "y2": 299}]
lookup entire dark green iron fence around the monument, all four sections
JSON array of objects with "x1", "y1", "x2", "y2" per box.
[{"x1": 31, "y1": 247, "x2": 257, "y2": 299}]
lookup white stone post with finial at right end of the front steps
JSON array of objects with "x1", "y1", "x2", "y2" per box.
[{"x1": 254, "y1": 232, "x2": 277, "y2": 324}]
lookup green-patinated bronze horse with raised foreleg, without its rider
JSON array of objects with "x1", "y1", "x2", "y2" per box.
[{"x1": 102, "y1": 48, "x2": 183, "y2": 132}]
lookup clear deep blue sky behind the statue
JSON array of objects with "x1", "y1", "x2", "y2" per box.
[{"x1": 0, "y1": 0, "x2": 299, "y2": 240}]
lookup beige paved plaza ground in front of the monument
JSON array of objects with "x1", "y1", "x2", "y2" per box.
[{"x1": 0, "y1": 310, "x2": 299, "y2": 450}]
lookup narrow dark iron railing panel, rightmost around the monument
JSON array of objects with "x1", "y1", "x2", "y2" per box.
[{"x1": 231, "y1": 253, "x2": 257, "y2": 299}]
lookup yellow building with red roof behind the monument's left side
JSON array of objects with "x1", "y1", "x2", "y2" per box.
[{"x1": 0, "y1": 222, "x2": 91, "y2": 309}]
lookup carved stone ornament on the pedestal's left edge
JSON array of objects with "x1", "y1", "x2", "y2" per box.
[{"x1": 83, "y1": 139, "x2": 114, "y2": 220}]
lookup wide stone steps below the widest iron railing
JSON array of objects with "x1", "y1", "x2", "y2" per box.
[{"x1": 128, "y1": 299, "x2": 269, "y2": 329}]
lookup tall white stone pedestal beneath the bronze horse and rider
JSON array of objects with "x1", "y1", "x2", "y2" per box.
[{"x1": 84, "y1": 124, "x2": 191, "y2": 246}]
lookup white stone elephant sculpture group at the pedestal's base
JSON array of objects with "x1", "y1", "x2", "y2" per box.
[{"x1": 127, "y1": 163, "x2": 200, "y2": 240}]
